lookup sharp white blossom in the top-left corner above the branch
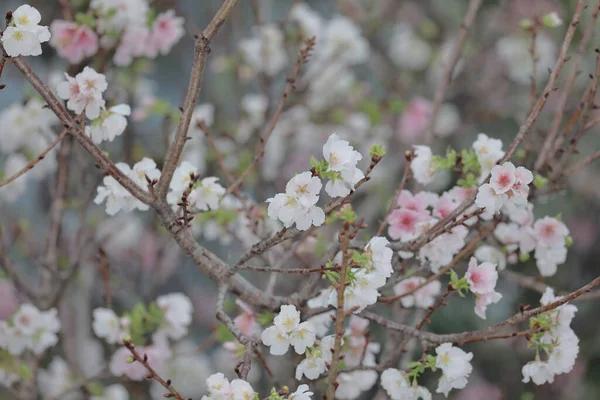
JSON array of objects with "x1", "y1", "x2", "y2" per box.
[{"x1": 2, "y1": 4, "x2": 51, "y2": 57}]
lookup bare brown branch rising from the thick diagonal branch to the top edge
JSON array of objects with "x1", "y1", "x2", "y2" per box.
[{"x1": 157, "y1": 0, "x2": 238, "y2": 200}]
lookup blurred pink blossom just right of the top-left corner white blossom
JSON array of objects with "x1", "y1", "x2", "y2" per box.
[{"x1": 50, "y1": 20, "x2": 98, "y2": 64}]
